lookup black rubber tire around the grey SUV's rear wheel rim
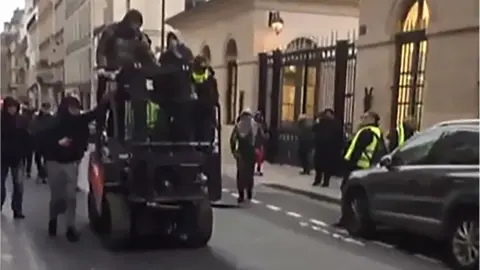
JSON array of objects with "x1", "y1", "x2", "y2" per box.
[{"x1": 445, "y1": 210, "x2": 479, "y2": 270}]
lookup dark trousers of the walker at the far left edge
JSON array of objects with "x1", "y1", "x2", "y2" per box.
[{"x1": 1, "y1": 164, "x2": 23, "y2": 213}]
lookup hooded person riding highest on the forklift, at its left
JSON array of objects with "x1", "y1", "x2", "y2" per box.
[{"x1": 96, "y1": 9, "x2": 157, "y2": 139}]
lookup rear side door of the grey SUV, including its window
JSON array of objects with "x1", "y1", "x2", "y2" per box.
[{"x1": 409, "y1": 127, "x2": 479, "y2": 229}]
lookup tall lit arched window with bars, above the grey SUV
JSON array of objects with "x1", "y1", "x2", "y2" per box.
[{"x1": 392, "y1": 0, "x2": 430, "y2": 127}]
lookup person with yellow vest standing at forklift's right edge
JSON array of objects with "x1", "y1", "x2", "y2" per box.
[{"x1": 192, "y1": 56, "x2": 219, "y2": 142}]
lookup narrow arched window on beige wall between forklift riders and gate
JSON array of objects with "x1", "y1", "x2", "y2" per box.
[{"x1": 225, "y1": 39, "x2": 238, "y2": 124}]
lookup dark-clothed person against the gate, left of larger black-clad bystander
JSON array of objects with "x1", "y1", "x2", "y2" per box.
[{"x1": 298, "y1": 114, "x2": 313, "y2": 175}]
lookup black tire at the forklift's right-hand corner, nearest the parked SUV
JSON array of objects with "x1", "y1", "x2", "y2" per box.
[{"x1": 185, "y1": 198, "x2": 213, "y2": 248}]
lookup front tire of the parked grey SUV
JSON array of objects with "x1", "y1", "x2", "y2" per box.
[{"x1": 343, "y1": 189, "x2": 375, "y2": 238}]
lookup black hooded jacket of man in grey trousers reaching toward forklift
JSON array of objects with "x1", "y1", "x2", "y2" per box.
[{"x1": 39, "y1": 97, "x2": 98, "y2": 163}]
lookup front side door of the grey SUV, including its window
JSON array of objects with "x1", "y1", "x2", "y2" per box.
[{"x1": 372, "y1": 130, "x2": 442, "y2": 225}]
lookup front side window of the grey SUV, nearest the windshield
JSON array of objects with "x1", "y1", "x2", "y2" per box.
[{"x1": 392, "y1": 129, "x2": 443, "y2": 165}]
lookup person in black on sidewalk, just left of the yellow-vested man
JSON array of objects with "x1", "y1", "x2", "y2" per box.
[{"x1": 313, "y1": 109, "x2": 345, "y2": 187}]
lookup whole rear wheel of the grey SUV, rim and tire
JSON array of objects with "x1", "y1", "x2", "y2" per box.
[{"x1": 447, "y1": 213, "x2": 479, "y2": 270}]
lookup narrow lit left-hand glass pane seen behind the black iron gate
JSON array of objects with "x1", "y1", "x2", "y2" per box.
[{"x1": 281, "y1": 66, "x2": 296, "y2": 122}]
